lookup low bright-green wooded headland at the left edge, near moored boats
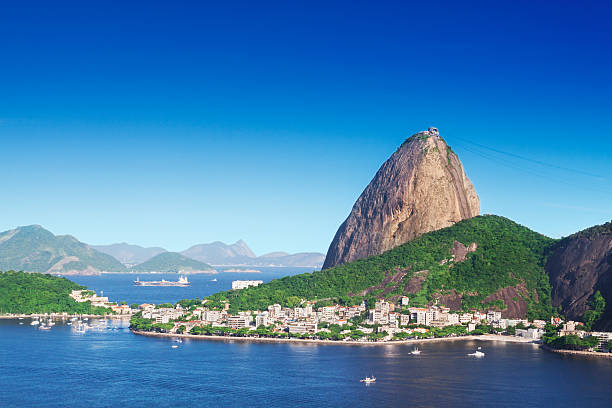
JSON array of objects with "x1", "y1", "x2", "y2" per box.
[{"x1": 0, "y1": 271, "x2": 111, "y2": 314}]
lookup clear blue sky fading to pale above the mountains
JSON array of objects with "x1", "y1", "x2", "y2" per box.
[{"x1": 0, "y1": 1, "x2": 612, "y2": 254}]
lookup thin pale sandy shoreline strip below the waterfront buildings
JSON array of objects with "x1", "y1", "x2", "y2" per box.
[{"x1": 130, "y1": 329, "x2": 539, "y2": 346}]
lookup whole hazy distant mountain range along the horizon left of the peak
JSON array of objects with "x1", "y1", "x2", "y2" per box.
[{"x1": 0, "y1": 225, "x2": 325, "y2": 275}]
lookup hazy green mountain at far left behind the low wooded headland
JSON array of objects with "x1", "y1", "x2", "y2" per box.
[{"x1": 0, "y1": 225, "x2": 125, "y2": 273}]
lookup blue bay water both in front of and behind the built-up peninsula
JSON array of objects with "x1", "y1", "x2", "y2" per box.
[{"x1": 0, "y1": 274, "x2": 612, "y2": 407}]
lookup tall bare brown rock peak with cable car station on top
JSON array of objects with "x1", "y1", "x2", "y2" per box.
[{"x1": 323, "y1": 130, "x2": 480, "y2": 269}]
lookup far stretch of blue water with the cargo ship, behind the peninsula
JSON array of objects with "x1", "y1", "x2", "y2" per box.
[{"x1": 68, "y1": 267, "x2": 312, "y2": 304}]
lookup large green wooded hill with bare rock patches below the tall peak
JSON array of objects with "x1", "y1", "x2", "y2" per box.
[{"x1": 209, "y1": 216, "x2": 556, "y2": 318}]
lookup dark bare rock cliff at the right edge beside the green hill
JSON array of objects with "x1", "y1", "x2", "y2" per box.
[{"x1": 546, "y1": 223, "x2": 612, "y2": 330}]
